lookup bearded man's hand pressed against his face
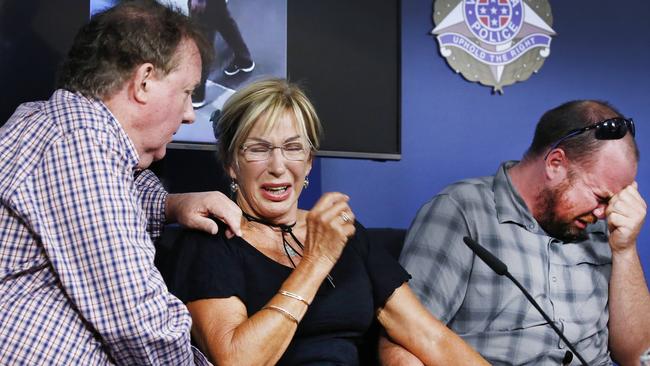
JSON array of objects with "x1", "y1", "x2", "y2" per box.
[{"x1": 605, "y1": 182, "x2": 647, "y2": 253}]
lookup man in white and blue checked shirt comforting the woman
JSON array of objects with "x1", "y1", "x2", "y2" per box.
[{"x1": 0, "y1": 1, "x2": 241, "y2": 365}]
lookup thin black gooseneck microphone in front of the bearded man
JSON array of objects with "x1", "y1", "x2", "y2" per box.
[{"x1": 463, "y1": 236, "x2": 588, "y2": 366}]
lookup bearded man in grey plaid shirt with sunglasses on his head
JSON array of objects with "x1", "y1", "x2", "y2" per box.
[{"x1": 381, "y1": 100, "x2": 650, "y2": 365}]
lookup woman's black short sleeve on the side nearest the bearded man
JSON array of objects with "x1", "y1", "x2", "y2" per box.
[{"x1": 355, "y1": 223, "x2": 411, "y2": 308}]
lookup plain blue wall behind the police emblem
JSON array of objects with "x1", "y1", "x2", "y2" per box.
[{"x1": 321, "y1": 0, "x2": 650, "y2": 278}]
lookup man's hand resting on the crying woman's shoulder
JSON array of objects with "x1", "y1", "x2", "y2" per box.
[{"x1": 165, "y1": 191, "x2": 242, "y2": 237}]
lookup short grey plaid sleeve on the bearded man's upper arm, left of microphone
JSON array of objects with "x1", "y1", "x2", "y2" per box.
[{"x1": 400, "y1": 194, "x2": 473, "y2": 323}]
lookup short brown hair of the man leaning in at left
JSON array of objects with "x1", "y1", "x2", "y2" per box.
[{"x1": 58, "y1": 0, "x2": 212, "y2": 99}]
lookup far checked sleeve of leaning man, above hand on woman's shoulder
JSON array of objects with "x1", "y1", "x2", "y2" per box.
[{"x1": 135, "y1": 170, "x2": 167, "y2": 242}]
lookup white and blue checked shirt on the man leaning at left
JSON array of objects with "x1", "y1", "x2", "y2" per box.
[{"x1": 0, "y1": 90, "x2": 205, "y2": 365}]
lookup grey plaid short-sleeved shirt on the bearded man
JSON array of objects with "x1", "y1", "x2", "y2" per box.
[{"x1": 400, "y1": 162, "x2": 612, "y2": 365}]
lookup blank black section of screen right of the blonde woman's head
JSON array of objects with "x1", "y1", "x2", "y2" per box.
[{"x1": 288, "y1": 0, "x2": 401, "y2": 159}]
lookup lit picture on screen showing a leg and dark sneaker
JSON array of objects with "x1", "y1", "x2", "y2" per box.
[{"x1": 90, "y1": 0, "x2": 287, "y2": 149}]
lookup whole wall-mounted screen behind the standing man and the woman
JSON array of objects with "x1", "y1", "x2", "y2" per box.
[{"x1": 0, "y1": 0, "x2": 400, "y2": 159}]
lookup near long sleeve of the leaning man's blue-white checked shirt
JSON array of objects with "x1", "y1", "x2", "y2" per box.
[{"x1": 16, "y1": 129, "x2": 201, "y2": 365}]
